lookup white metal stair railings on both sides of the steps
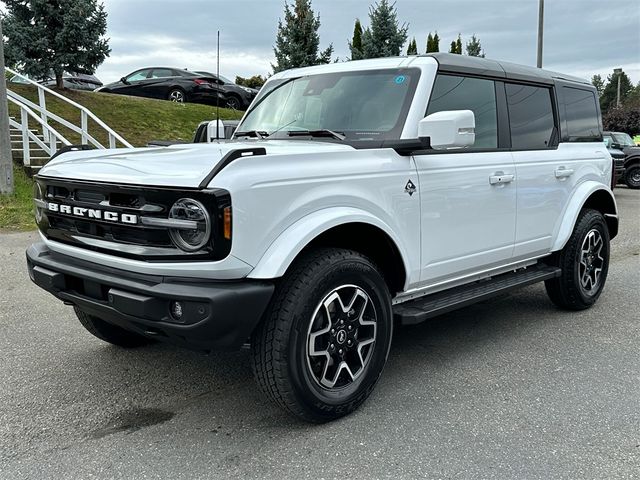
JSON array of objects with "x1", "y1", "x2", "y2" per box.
[{"x1": 5, "y1": 68, "x2": 132, "y2": 166}]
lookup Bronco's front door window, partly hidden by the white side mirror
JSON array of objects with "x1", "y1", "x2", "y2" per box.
[{"x1": 427, "y1": 75, "x2": 498, "y2": 148}]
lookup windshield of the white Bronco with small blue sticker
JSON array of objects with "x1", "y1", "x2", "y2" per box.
[{"x1": 238, "y1": 69, "x2": 420, "y2": 140}]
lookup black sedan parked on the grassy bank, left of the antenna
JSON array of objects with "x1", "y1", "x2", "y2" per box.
[{"x1": 96, "y1": 67, "x2": 227, "y2": 105}]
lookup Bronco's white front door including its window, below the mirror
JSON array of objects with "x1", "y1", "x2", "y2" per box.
[{"x1": 415, "y1": 74, "x2": 516, "y2": 284}]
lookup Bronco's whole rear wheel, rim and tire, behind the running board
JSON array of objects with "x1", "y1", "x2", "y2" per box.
[{"x1": 545, "y1": 209, "x2": 609, "y2": 310}]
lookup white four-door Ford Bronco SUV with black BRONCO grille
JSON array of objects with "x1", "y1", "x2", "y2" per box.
[{"x1": 27, "y1": 54, "x2": 618, "y2": 422}]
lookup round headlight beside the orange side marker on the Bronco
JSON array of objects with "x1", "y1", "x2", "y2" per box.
[{"x1": 169, "y1": 198, "x2": 211, "y2": 252}]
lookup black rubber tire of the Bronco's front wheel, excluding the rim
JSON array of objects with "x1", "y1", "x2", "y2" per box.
[{"x1": 251, "y1": 248, "x2": 393, "y2": 423}]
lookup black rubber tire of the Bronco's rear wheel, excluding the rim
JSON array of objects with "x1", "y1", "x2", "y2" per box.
[{"x1": 545, "y1": 209, "x2": 610, "y2": 310}]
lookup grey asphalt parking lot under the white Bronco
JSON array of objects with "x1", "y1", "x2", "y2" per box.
[{"x1": 0, "y1": 187, "x2": 640, "y2": 480}]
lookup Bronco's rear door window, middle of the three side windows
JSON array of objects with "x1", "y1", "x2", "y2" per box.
[{"x1": 505, "y1": 83, "x2": 555, "y2": 150}]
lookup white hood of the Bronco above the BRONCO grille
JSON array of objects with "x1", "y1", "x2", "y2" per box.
[{"x1": 39, "y1": 140, "x2": 354, "y2": 188}]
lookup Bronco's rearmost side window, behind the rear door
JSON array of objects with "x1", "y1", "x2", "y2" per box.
[{"x1": 562, "y1": 87, "x2": 602, "y2": 142}]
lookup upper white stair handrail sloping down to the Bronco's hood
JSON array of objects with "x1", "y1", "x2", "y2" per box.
[{"x1": 5, "y1": 67, "x2": 133, "y2": 148}]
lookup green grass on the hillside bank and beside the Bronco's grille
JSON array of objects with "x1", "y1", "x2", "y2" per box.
[{"x1": 0, "y1": 84, "x2": 242, "y2": 231}]
